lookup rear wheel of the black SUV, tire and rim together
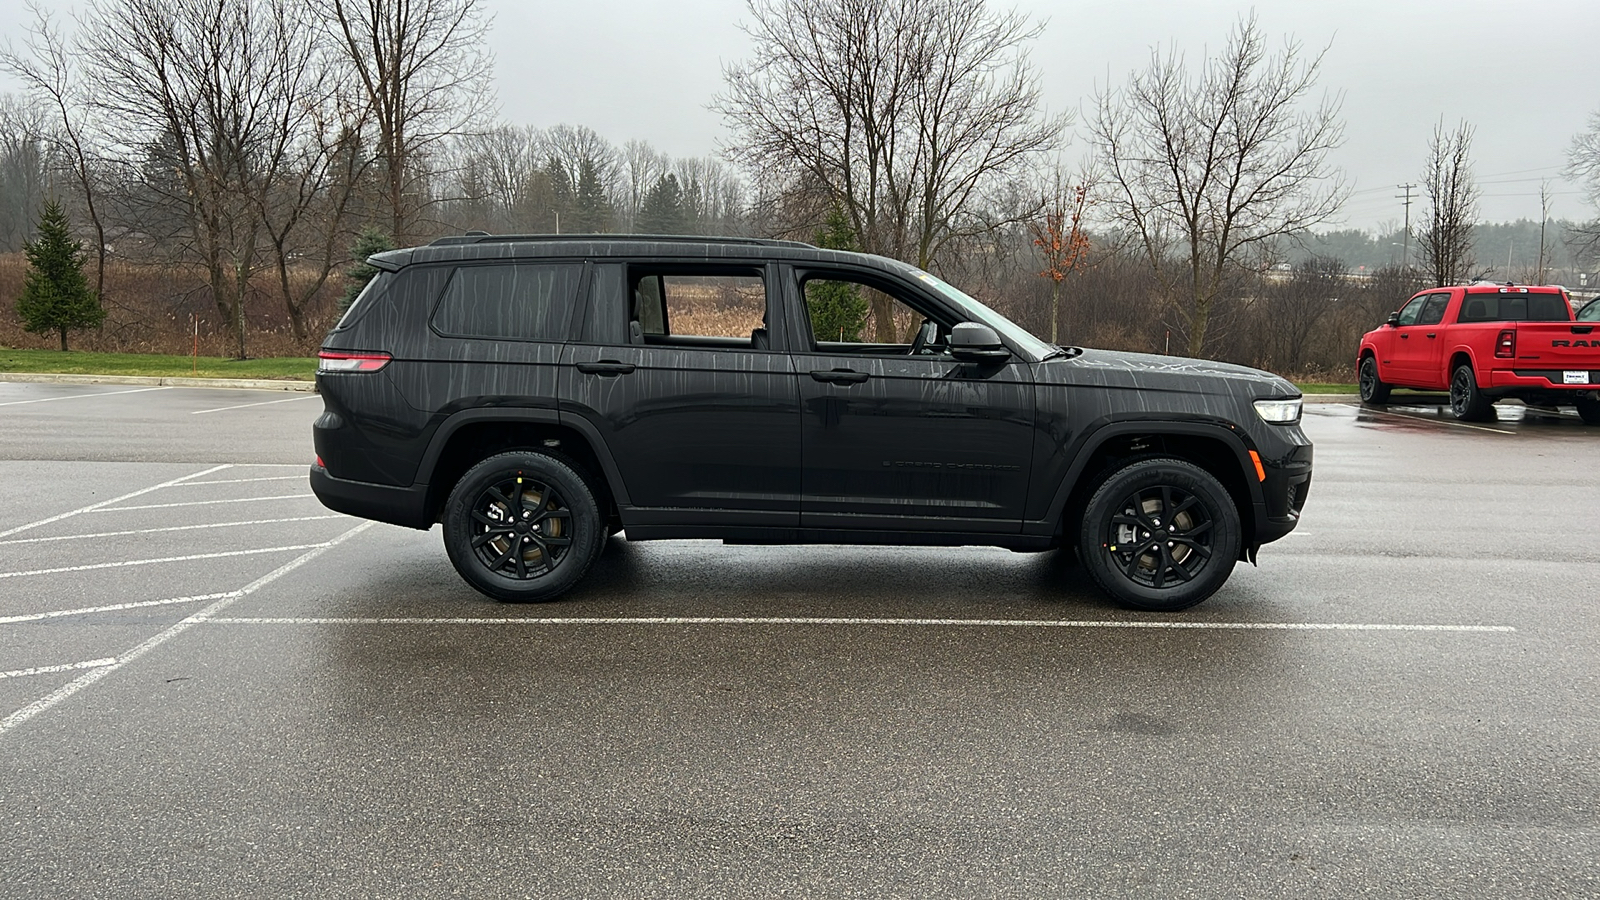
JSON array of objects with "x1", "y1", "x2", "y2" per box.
[{"x1": 445, "y1": 450, "x2": 606, "y2": 602}]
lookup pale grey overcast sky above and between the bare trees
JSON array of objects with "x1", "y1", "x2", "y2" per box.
[{"x1": 0, "y1": 0, "x2": 1600, "y2": 229}]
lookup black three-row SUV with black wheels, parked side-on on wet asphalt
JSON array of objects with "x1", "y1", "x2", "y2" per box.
[{"x1": 310, "y1": 235, "x2": 1312, "y2": 610}]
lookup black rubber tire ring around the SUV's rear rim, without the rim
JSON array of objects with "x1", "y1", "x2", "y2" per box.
[{"x1": 445, "y1": 450, "x2": 606, "y2": 602}]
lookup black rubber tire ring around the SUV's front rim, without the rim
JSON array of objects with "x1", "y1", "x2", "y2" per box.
[{"x1": 1078, "y1": 458, "x2": 1243, "y2": 612}]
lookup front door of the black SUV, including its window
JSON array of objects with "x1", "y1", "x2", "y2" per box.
[{"x1": 789, "y1": 269, "x2": 1034, "y2": 533}]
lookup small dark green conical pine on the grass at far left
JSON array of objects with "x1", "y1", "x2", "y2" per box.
[{"x1": 16, "y1": 200, "x2": 106, "y2": 351}]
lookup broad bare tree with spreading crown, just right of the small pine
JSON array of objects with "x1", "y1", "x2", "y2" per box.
[{"x1": 80, "y1": 0, "x2": 315, "y2": 357}]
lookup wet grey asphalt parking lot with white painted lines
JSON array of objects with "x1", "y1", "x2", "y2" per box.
[{"x1": 0, "y1": 384, "x2": 1600, "y2": 898}]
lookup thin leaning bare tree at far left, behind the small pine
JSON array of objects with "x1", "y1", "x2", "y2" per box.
[{"x1": 0, "y1": 6, "x2": 106, "y2": 304}]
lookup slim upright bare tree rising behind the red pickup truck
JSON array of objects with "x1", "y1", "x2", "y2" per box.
[{"x1": 1416, "y1": 120, "x2": 1478, "y2": 287}]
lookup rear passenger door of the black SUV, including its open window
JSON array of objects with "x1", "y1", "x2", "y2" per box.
[{"x1": 562, "y1": 261, "x2": 800, "y2": 528}]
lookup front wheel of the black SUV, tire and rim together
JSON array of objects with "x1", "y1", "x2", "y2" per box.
[{"x1": 1078, "y1": 458, "x2": 1242, "y2": 612}]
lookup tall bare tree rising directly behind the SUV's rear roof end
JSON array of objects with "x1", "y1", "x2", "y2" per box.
[{"x1": 314, "y1": 0, "x2": 494, "y2": 245}]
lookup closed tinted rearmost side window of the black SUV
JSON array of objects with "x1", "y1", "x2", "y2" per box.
[{"x1": 434, "y1": 263, "x2": 582, "y2": 341}]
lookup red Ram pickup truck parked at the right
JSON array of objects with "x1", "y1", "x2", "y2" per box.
[{"x1": 1355, "y1": 282, "x2": 1600, "y2": 424}]
